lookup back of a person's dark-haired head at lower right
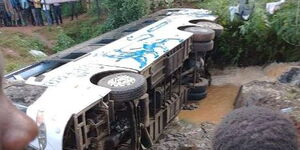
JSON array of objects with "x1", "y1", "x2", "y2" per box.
[{"x1": 213, "y1": 106, "x2": 298, "y2": 150}]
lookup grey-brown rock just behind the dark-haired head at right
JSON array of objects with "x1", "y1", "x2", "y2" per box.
[{"x1": 235, "y1": 81, "x2": 300, "y2": 122}]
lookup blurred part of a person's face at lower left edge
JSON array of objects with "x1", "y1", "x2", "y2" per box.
[{"x1": 0, "y1": 55, "x2": 37, "y2": 150}]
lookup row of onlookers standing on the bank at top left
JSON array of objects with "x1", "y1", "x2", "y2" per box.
[{"x1": 0, "y1": 0, "x2": 78, "y2": 27}]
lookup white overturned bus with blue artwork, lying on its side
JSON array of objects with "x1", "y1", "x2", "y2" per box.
[{"x1": 4, "y1": 9, "x2": 220, "y2": 150}]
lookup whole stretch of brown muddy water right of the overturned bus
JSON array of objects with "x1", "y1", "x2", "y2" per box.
[{"x1": 179, "y1": 63, "x2": 297, "y2": 124}]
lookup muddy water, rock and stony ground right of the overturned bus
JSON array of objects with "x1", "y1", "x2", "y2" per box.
[{"x1": 152, "y1": 63, "x2": 300, "y2": 150}]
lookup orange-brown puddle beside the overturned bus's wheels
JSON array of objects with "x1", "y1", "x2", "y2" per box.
[{"x1": 179, "y1": 85, "x2": 239, "y2": 124}]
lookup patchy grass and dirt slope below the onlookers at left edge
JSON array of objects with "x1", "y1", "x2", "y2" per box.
[{"x1": 0, "y1": 14, "x2": 89, "y2": 73}]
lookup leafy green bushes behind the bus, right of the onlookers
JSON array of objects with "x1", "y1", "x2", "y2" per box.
[{"x1": 53, "y1": 0, "x2": 148, "y2": 52}]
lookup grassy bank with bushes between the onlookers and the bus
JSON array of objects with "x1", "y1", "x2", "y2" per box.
[{"x1": 0, "y1": 0, "x2": 148, "y2": 72}]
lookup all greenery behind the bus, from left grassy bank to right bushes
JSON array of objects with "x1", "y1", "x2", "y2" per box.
[{"x1": 0, "y1": 0, "x2": 300, "y2": 72}]
